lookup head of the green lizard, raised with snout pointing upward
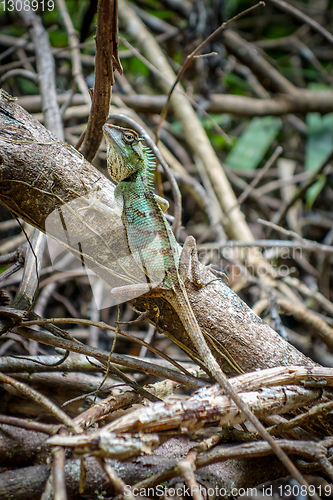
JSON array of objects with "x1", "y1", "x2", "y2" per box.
[{"x1": 103, "y1": 123, "x2": 144, "y2": 182}]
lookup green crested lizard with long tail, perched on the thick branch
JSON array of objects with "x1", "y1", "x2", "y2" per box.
[{"x1": 103, "y1": 124, "x2": 307, "y2": 485}]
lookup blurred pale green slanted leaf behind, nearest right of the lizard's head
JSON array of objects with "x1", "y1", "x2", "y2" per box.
[{"x1": 225, "y1": 116, "x2": 282, "y2": 170}]
